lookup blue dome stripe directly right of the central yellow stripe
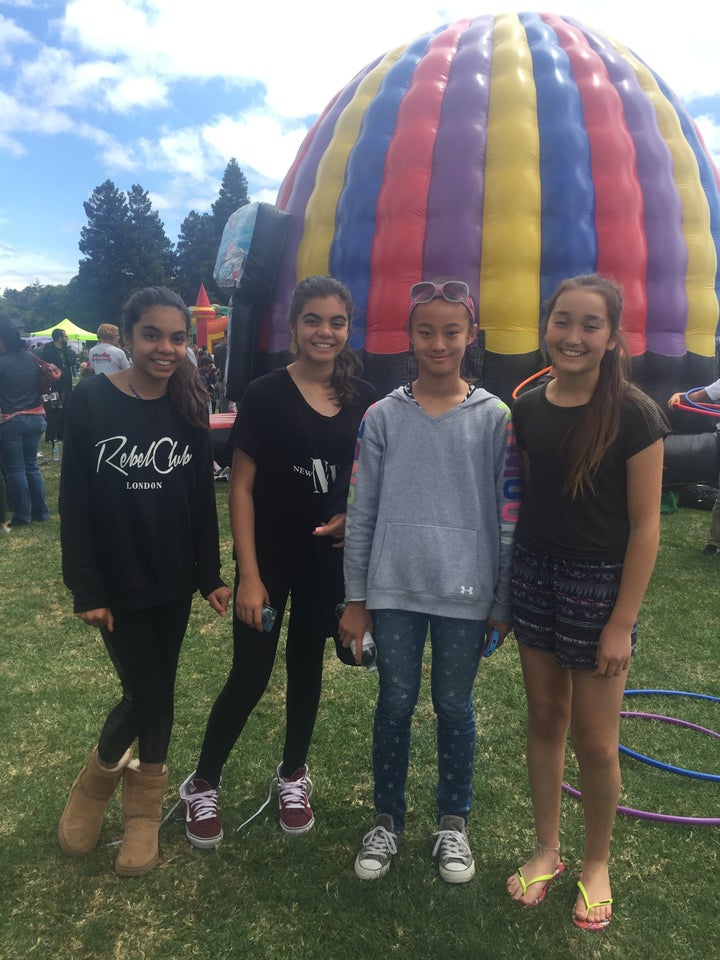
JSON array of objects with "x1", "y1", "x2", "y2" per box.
[{"x1": 520, "y1": 13, "x2": 598, "y2": 312}]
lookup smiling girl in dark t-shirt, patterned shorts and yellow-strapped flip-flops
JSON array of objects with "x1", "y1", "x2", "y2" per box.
[{"x1": 507, "y1": 274, "x2": 669, "y2": 930}]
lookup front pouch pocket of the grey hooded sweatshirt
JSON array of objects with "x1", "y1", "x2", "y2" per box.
[{"x1": 370, "y1": 522, "x2": 484, "y2": 603}]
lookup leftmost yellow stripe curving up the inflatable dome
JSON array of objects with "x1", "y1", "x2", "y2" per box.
[{"x1": 295, "y1": 44, "x2": 407, "y2": 280}]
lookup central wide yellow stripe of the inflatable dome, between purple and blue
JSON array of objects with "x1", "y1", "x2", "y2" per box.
[{"x1": 479, "y1": 14, "x2": 541, "y2": 354}]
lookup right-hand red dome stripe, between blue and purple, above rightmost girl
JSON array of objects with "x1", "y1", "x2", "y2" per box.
[{"x1": 543, "y1": 14, "x2": 647, "y2": 356}]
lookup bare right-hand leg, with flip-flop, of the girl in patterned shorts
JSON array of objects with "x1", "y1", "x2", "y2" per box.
[{"x1": 572, "y1": 670, "x2": 627, "y2": 922}]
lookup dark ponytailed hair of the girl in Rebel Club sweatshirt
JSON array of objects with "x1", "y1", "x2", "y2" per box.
[{"x1": 123, "y1": 287, "x2": 210, "y2": 428}]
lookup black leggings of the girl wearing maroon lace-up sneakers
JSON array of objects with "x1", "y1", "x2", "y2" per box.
[{"x1": 197, "y1": 544, "x2": 334, "y2": 788}]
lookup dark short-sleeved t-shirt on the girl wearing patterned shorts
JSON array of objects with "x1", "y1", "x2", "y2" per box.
[{"x1": 513, "y1": 386, "x2": 670, "y2": 562}]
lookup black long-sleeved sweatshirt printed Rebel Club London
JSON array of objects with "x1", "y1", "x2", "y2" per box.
[{"x1": 59, "y1": 374, "x2": 223, "y2": 613}]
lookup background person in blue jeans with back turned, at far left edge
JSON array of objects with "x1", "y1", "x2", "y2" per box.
[{"x1": 0, "y1": 316, "x2": 50, "y2": 527}]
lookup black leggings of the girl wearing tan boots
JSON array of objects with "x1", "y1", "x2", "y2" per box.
[{"x1": 98, "y1": 597, "x2": 192, "y2": 764}]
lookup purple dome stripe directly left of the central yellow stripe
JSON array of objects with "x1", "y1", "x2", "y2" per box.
[{"x1": 423, "y1": 16, "x2": 495, "y2": 303}]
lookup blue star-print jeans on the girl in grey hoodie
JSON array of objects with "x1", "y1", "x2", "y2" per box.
[{"x1": 373, "y1": 610, "x2": 485, "y2": 831}]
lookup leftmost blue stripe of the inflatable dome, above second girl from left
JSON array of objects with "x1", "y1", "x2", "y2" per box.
[{"x1": 330, "y1": 34, "x2": 434, "y2": 350}]
